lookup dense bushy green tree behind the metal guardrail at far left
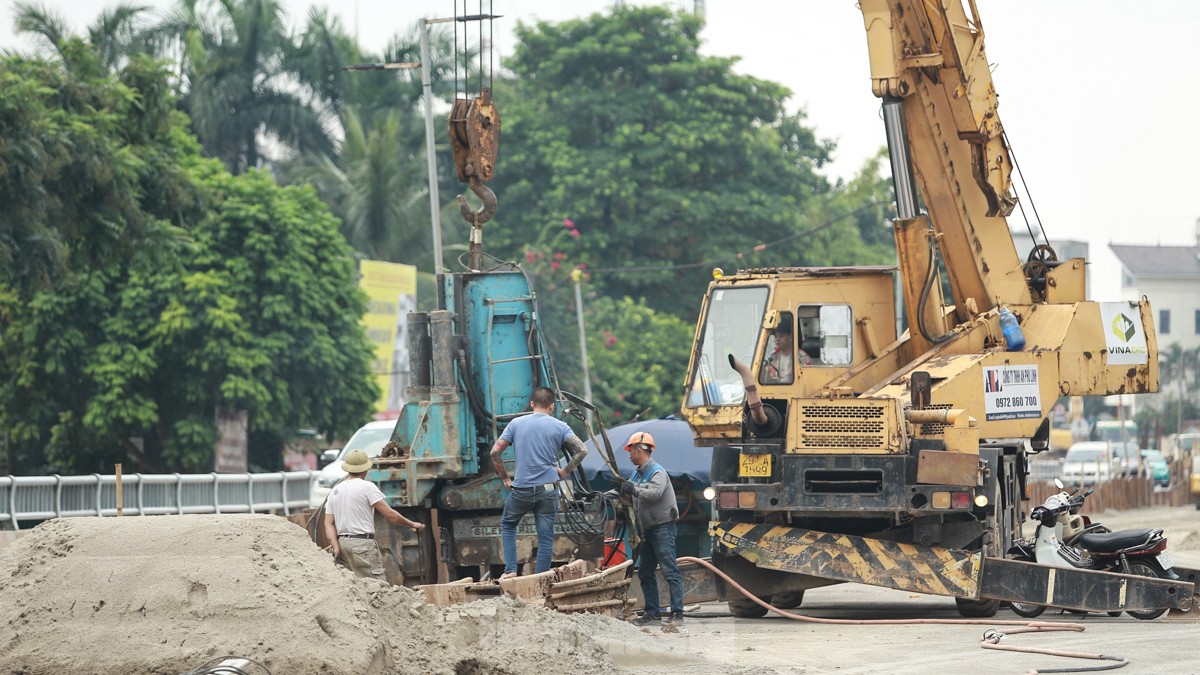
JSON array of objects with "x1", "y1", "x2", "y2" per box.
[{"x1": 0, "y1": 47, "x2": 376, "y2": 473}]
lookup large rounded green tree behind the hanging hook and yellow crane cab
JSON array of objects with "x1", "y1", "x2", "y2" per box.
[{"x1": 487, "y1": 7, "x2": 853, "y2": 316}]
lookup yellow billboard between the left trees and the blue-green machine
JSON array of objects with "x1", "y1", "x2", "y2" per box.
[{"x1": 359, "y1": 261, "x2": 416, "y2": 418}]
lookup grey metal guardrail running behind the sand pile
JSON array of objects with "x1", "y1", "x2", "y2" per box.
[{"x1": 0, "y1": 471, "x2": 317, "y2": 530}]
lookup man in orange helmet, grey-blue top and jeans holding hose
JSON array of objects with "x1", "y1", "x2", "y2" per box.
[{"x1": 620, "y1": 431, "x2": 683, "y2": 626}]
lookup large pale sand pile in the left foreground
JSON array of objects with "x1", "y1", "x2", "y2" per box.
[{"x1": 0, "y1": 515, "x2": 653, "y2": 675}]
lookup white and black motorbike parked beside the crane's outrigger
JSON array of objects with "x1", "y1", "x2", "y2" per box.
[{"x1": 1009, "y1": 479, "x2": 1180, "y2": 621}]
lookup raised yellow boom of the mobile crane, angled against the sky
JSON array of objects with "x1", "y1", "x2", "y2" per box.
[{"x1": 859, "y1": 0, "x2": 1032, "y2": 336}]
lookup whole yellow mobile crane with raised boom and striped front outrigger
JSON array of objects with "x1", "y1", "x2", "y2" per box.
[{"x1": 683, "y1": 0, "x2": 1192, "y2": 616}]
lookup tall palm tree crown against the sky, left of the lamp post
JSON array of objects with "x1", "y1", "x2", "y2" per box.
[{"x1": 156, "y1": 0, "x2": 332, "y2": 173}]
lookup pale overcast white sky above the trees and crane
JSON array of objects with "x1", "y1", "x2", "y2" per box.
[{"x1": 0, "y1": 0, "x2": 1200, "y2": 300}]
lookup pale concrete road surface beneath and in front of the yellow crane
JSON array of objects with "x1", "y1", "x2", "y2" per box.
[{"x1": 610, "y1": 507, "x2": 1200, "y2": 675}]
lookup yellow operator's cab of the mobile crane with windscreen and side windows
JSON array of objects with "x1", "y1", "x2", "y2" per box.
[{"x1": 683, "y1": 267, "x2": 896, "y2": 441}]
